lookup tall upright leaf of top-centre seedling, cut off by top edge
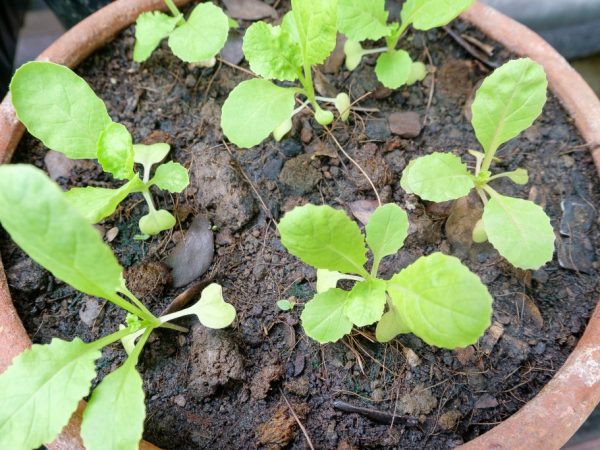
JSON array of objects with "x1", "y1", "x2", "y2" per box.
[{"x1": 292, "y1": 0, "x2": 337, "y2": 65}]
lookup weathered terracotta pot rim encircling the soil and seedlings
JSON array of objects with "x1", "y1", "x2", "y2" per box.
[{"x1": 0, "y1": 0, "x2": 600, "y2": 450}]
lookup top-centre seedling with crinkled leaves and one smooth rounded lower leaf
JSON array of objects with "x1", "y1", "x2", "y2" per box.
[{"x1": 221, "y1": 0, "x2": 350, "y2": 148}]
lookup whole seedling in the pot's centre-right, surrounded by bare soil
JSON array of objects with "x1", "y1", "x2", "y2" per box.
[{"x1": 278, "y1": 203, "x2": 492, "y2": 349}]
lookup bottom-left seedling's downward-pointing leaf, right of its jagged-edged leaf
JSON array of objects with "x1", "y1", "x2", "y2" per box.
[{"x1": 81, "y1": 362, "x2": 146, "y2": 450}]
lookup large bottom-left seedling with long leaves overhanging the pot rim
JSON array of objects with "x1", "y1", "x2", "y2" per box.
[{"x1": 0, "y1": 165, "x2": 235, "y2": 450}]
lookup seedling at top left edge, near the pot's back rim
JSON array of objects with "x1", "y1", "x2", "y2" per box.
[{"x1": 133, "y1": 0, "x2": 230, "y2": 67}]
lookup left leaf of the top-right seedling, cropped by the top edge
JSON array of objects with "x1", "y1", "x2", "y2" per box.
[{"x1": 338, "y1": 0, "x2": 390, "y2": 41}]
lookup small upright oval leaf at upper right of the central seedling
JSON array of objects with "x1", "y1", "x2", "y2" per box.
[{"x1": 365, "y1": 203, "x2": 408, "y2": 261}]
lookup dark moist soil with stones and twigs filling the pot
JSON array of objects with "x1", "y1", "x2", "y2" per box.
[{"x1": 0, "y1": 1, "x2": 600, "y2": 449}]
